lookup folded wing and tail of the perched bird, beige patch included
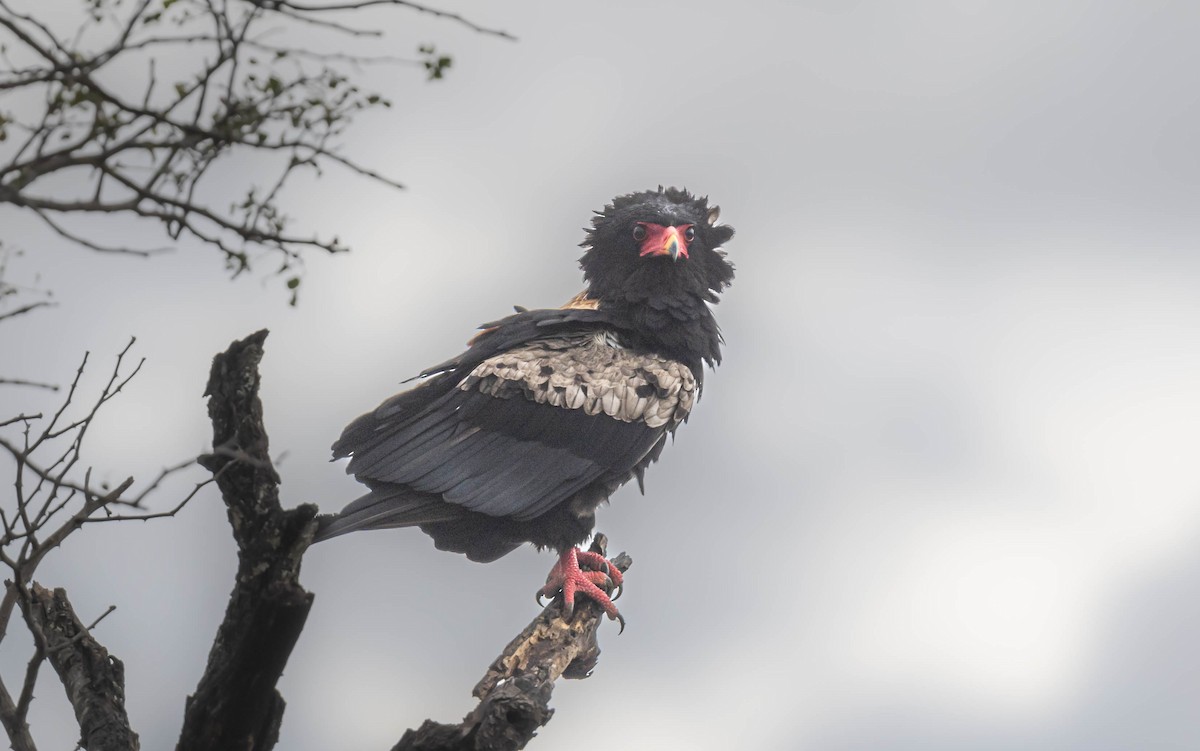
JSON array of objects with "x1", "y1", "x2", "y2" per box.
[{"x1": 318, "y1": 311, "x2": 698, "y2": 539}]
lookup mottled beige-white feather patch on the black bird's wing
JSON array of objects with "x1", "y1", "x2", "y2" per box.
[{"x1": 458, "y1": 332, "x2": 697, "y2": 428}]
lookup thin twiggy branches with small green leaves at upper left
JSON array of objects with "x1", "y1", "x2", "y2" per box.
[{"x1": 0, "y1": 0, "x2": 512, "y2": 304}]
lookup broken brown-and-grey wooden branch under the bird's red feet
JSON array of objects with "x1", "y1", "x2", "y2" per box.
[{"x1": 392, "y1": 534, "x2": 632, "y2": 751}]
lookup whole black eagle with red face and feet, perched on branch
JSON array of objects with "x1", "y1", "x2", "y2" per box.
[{"x1": 317, "y1": 187, "x2": 733, "y2": 618}]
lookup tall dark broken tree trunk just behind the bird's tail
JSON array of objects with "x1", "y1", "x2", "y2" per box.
[{"x1": 178, "y1": 330, "x2": 317, "y2": 751}]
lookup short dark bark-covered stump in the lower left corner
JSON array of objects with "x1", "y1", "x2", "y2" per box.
[{"x1": 24, "y1": 582, "x2": 139, "y2": 751}]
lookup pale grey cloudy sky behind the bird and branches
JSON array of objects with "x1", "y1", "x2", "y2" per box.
[{"x1": 0, "y1": 0, "x2": 1200, "y2": 751}]
